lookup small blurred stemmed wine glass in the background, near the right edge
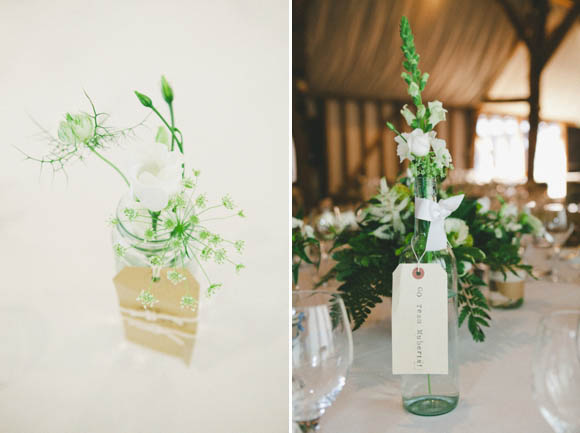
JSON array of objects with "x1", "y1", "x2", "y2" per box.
[{"x1": 543, "y1": 203, "x2": 574, "y2": 282}]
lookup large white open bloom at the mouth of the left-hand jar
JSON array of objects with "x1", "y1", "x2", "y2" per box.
[{"x1": 129, "y1": 142, "x2": 183, "y2": 212}]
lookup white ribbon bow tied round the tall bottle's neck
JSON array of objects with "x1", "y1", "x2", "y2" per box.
[{"x1": 415, "y1": 194, "x2": 463, "y2": 251}]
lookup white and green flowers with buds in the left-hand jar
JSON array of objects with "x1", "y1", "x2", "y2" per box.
[{"x1": 25, "y1": 77, "x2": 245, "y2": 311}]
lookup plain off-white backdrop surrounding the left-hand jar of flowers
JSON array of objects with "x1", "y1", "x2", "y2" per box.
[{"x1": 0, "y1": 0, "x2": 289, "y2": 433}]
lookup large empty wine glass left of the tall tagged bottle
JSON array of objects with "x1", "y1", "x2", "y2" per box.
[{"x1": 292, "y1": 290, "x2": 353, "y2": 432}]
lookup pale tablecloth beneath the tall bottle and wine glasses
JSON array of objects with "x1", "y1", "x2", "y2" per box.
[{"x1": 321, "y1": 281, "x2": 580, "y2": 433}]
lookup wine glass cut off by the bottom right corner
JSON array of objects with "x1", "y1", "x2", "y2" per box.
[{"x1": 533, "y1": 310, "x2": 580, "y2": 433}]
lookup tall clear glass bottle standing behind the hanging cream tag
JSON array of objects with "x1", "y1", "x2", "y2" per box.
[{"x1": 399, "y1": 177, "x2": 459, "y2": 416}]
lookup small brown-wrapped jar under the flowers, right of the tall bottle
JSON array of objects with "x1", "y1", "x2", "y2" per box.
[{"x1": 487, "y1": 271, "x2": 526, "y2": 310}]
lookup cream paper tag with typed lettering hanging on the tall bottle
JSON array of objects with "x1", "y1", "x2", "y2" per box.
[{"x1": 392, "y1": 263, "x2": 448, "y2": 374}]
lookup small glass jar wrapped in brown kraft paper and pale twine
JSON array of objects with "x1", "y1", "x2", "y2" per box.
[{"x1": 112, "y1": 195, "x2": 199, "y2": 364}]
